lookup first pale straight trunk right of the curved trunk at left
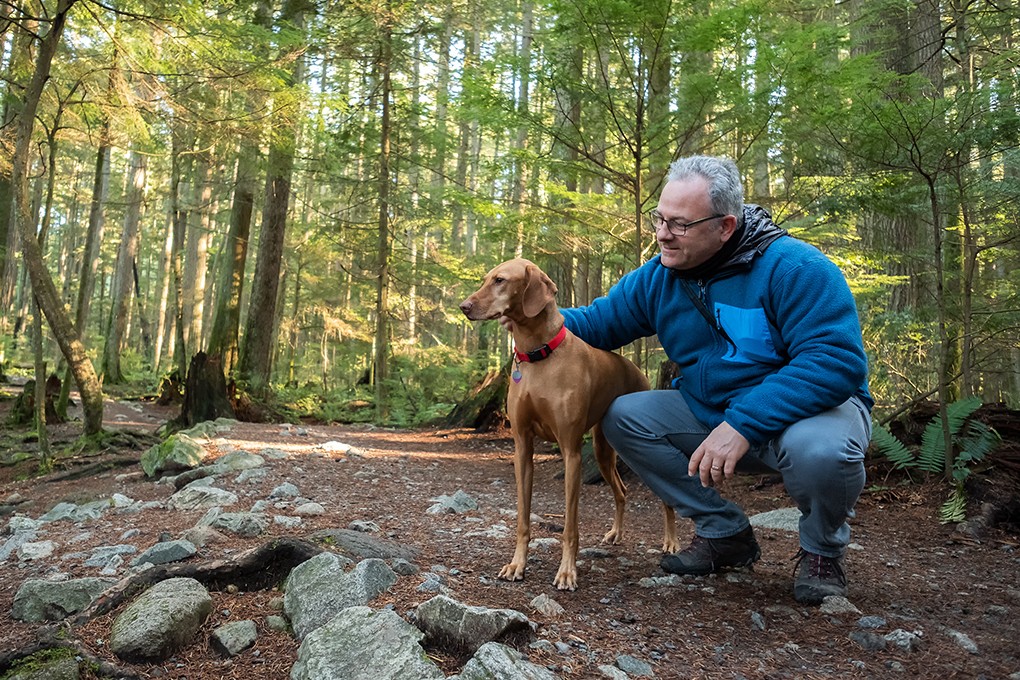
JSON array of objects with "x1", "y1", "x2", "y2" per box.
[{"x1": 103, "y1": 151, "x2": 148, "y2": 384}]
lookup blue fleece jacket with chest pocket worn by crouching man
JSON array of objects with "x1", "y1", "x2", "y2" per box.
[{"x1": 562, "y1": 206, "x2": 873, "y2": 446}]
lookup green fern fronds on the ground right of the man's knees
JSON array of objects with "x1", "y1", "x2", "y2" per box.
[{"x1": 871, "y1": 397, "x2": 1001, "y2": 524}]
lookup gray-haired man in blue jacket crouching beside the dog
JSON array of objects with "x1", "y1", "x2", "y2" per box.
[{"x1": 563, "y1": 156, "x2": 873, "y2": 604}]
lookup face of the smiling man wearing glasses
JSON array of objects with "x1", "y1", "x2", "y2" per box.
[{"x1": 655, "y1": 177, "x2": 736, "y2": 269}]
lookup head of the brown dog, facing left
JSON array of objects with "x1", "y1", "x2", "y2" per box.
[{"x1": 460, "y1": 258, "x2": 556, "y2": 321}]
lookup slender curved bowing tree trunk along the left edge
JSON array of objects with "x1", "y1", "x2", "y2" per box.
[{"x1": 11, "y1": 0, "x2": 103, "y2": 434}]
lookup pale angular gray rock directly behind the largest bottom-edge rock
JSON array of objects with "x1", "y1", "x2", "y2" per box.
[{"x1": 284, "y1": 553, "x2": 397, "y2": 639}]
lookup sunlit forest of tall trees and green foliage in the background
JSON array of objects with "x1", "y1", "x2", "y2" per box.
[{"x1": 0, "y1": 0, "x2": 1020, "y2": 433}]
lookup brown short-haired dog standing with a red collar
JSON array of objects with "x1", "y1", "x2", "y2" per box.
[{"x1": 460, "y1": 259, "x2": 679, "y2": 590}]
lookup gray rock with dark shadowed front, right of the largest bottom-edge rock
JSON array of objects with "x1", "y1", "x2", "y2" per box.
[{"x1": 416, "y1": 595, "x2": 531, "y2": 652}]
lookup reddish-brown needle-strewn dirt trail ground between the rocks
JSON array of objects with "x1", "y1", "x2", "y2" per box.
[{"x1": 0, "y1": 386, "x2": 1020, "y2": 680}]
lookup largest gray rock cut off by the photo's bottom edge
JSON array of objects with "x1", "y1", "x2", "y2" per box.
[{"x1": 291, "y1": 607, "x2": 446, "y2": 680}]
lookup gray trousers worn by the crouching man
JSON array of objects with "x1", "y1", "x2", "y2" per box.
[{"x1": 602, "y1": 389, "x2": 871, "y2": 558}]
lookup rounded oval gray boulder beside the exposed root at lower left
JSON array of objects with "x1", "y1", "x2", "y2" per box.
[{"x1": 110, "y1": 578, "x2": 212, "y2": 662}]
